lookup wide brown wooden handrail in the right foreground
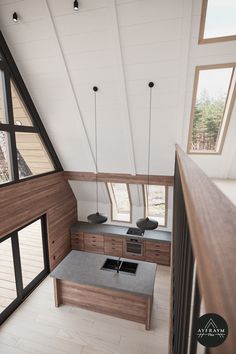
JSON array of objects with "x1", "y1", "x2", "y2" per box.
[{"x1": 176, "y1": 146, "x2": 236, "y2": 354}]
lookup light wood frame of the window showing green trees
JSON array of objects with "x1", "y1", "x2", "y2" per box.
[{"x1": 187, "y1": 62, "x2": 236, "y2": 155}]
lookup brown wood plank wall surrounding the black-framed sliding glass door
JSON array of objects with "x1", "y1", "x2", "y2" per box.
[{"x1": 0, "y1": 172, "x2": 77, "y2": 270}]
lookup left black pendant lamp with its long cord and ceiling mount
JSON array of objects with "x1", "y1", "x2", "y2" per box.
[{"x1": 87, "y1": 86, "x2": 107, "y2": 224}]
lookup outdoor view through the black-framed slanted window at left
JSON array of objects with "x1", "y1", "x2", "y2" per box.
[{"x1": 0, "y1": 70, "x2": 54, "y2": 184}]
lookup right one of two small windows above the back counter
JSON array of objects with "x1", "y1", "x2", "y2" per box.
[{"x1": 143, "y1": 184, "x2": 167, "y2": 226}]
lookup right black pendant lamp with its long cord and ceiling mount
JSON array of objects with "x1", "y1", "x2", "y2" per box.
[{"x1": 136, "y1": 82, "x2": 158, "y2": 230}]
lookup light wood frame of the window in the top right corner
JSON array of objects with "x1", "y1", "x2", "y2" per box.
[{"x1": 198, "y1": 0, "x2": 236, "y2": 44}]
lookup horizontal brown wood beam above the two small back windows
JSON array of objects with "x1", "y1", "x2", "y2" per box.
[{"x1": 64, "y1": 171, "x2": 174, "y2": 186}]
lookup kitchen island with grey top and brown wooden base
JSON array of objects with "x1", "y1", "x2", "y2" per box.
[{"x1": 51, "y1": 251, "x2": 157, "y2": 329}]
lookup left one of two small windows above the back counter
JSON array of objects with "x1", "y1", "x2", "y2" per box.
[{"x1": 107, "y1": 183, "x2": 131, "y2": 222}]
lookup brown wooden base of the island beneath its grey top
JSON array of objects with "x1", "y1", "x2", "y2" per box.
[{"x1": 54, "y1": 278, "x2": 153, "y2": 330}]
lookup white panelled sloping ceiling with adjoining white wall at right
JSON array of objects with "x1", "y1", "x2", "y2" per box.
[{"x1": 0, "y1": 0, "x2": 236, "y2": 177}]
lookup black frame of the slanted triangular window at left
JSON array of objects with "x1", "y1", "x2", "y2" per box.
[{"x1": 0, "y1": 31, "x2": 63, "y2": 188}]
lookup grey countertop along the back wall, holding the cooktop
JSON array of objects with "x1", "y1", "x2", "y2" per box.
[{"x1": 70, "y1": 221, "x2": 171, "y2": 242}]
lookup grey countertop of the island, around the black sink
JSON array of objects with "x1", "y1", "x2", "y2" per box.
[{"x1": 51, "y1": 251, "x2": 157, "y2": 296}]
